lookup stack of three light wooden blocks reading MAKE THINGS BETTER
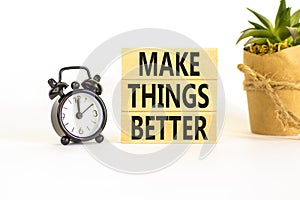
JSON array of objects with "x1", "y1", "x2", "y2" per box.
[{"x1": 121, "y1": 48, "x2": 218, "y2": 143}]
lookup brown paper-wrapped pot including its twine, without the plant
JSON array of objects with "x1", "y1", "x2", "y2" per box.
[{"x1": 238, "y1": 46, "x2": 300, "y2": 136}]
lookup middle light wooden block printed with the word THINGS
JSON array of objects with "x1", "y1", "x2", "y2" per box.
[{"x1": 121, "y1": 79, "x2": 218, "y2": 112}]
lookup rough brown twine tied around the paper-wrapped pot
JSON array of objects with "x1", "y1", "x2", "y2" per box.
[{"x1": 238, "y1": 64, "x2": 300, "y2": 129}]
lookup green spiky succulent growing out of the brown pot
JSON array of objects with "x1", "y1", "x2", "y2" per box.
[{"x1": 237, "y1": 0, "x2": 300, "y2": 54}]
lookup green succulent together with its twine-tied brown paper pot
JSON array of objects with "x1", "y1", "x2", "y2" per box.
[{"x1": 237, "y1": 0, "x2": 300, "y2": 136}]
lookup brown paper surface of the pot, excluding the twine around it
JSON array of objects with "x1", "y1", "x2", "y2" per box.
[{"x1": 244, "y1": 46, "x2": 300, "y2": 136}]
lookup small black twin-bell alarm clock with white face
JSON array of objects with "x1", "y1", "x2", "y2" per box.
[{"x1": 48, "y1": 66, "x2": 107, "y2": 145}]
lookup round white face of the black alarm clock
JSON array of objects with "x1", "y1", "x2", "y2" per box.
[{"x1": 60, "y1": 92, "x2": 105, "y2": 138}]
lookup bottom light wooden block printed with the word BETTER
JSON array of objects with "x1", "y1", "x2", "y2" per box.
[{"x1": 121, "y1": 111, "x2": 216, "y2": 144}]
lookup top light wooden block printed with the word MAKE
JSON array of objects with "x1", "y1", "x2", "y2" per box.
[{"x1": 122, "y1": 48, "x2": 218, "y2": 81}]
